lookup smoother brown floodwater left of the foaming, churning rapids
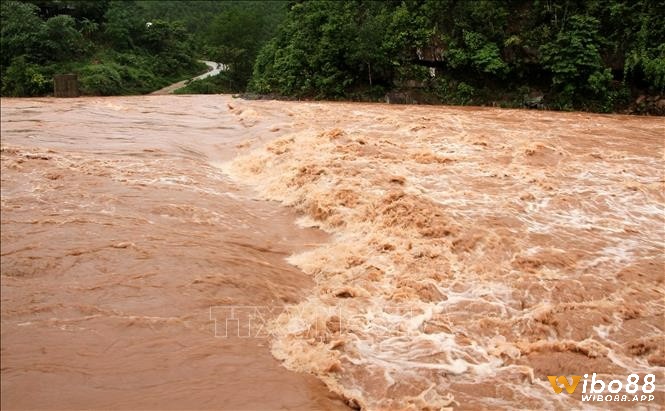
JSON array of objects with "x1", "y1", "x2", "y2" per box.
[{"x1": 2, "y1": 96, "x2": 344, "y2": 410}]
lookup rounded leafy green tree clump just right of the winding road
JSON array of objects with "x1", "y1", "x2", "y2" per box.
[{"x1": 250, "y1": 1, "x2": 402, "y2": 98}]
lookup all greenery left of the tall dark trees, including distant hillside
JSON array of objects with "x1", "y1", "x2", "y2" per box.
[{"x1": 0, "y1": 0, "x2": 286, "y2": 96}]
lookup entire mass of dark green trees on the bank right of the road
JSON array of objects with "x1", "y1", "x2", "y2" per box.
[{"x1": 250, "y1": 0, "x2": 665, "y2": 111}]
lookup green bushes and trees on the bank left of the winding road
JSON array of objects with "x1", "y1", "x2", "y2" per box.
[{"x1": 0, "y1": 0, "x2": 204, "y2": 96}]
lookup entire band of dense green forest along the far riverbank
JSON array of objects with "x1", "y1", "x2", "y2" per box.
[{"x1": 1, "y1": 0, "x2": 665, "y2": 114}]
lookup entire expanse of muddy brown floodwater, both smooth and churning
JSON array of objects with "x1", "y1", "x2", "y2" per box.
[{"x1": 1, "y1": 96, "x2": 665, "y2": 410}]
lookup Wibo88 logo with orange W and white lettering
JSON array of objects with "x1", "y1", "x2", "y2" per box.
[{"x1": 547, "y1": 372, "x2": 656, "y2": 401}]
